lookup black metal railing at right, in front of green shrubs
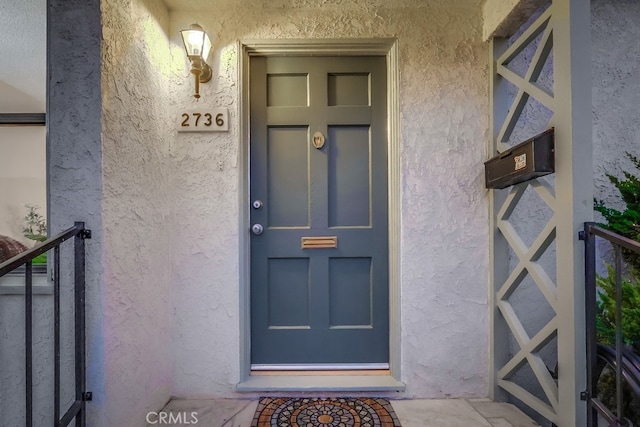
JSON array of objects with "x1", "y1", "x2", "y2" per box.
[{"x1": 580, "y1": 222, "x2": 640, "y2": 427}]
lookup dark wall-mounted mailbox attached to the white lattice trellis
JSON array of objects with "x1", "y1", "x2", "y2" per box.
[{"x1": 484, "y1": 128, "x2": 555, "y2": 188}]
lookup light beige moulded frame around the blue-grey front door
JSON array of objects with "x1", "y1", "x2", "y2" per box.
[{"x1": 237, "y1": 39, "x2": 401, "y2": 391}]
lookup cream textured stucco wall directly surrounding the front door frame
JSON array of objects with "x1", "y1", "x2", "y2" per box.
[{"x1": 171, "y1": 0, "x2": 488, "y2": 397}]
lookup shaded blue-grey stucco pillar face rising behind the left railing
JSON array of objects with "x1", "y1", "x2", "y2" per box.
[{"x1": 43, "y1": 0, "x2": 107, "y2": 425}]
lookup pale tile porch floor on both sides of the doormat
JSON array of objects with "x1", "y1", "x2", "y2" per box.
[{"x1": 149, "y1": 399, "x2": 537, "y2": 427}]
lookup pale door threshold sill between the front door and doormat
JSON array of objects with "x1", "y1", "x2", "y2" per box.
[{"x1": 236, "y1": 371, "x2": 405, "y2": 392}]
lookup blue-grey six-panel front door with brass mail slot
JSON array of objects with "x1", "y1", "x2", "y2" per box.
[{"x1": 250, "y1": 56, "x2": 389, "y2": 369}]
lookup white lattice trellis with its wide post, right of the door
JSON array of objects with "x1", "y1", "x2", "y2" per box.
[{"x1": 489, "y1": 0, "x2": 593, "y2": 427}]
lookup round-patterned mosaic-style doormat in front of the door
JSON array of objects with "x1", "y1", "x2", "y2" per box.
[{"x1": 251, "y1": 397, "x2": 401, "y2": 427}]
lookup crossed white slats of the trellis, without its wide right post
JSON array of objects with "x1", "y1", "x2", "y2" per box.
[{"x1": 492, "y1": 7, "x2": 559, "y2": 423}]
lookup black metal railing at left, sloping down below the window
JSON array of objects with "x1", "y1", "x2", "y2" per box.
[{"x1": 0, "y1": 222, "x2": 91, "y2": 427}]
